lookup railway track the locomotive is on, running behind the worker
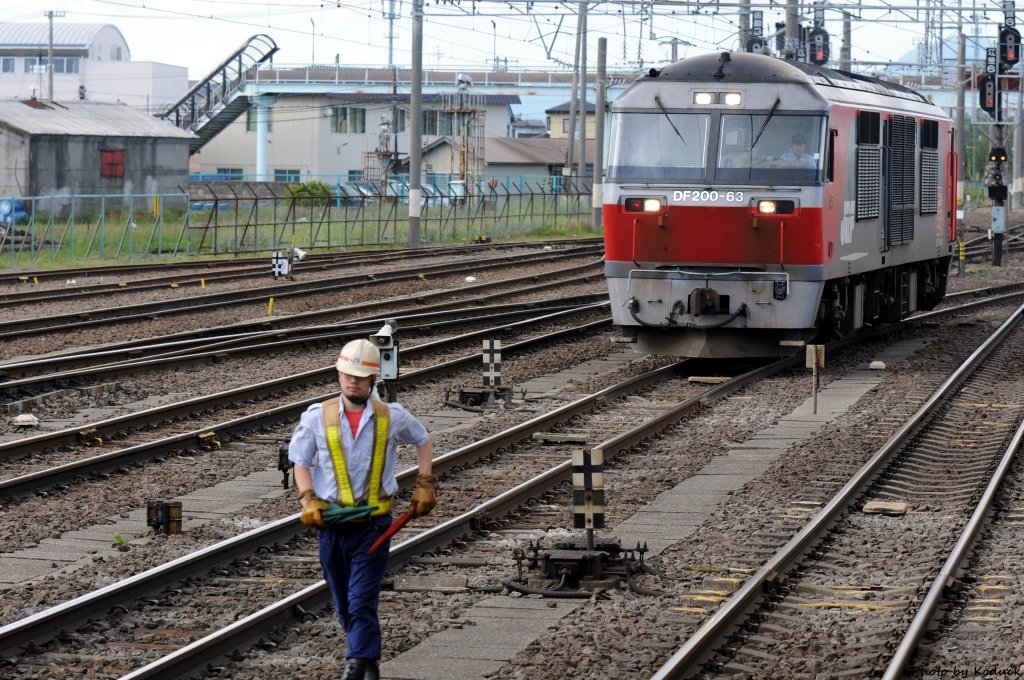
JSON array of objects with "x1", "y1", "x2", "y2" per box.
[{"x1": 0, "y1": 348, "x2": 783, "y2": 677}]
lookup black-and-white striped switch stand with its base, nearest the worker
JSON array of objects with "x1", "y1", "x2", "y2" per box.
[{"x1": 502, "y1": 449, "x2": 662, "y2": 598}]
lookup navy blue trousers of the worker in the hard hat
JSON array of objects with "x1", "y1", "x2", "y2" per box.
[{"x1": 319, "y1": 517, "x2": 391, "y2": 658}]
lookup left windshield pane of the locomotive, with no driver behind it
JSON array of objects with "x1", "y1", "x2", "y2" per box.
[{"x1": 608, "y1": 112, "x2": 711, "y2": 180}]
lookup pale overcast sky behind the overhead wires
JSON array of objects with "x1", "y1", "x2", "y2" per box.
[{"x1": 8, "y1": 0, "x2": 1001, "y2": 78}]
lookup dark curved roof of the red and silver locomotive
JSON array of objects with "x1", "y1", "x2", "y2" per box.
[{"x1": 641, "y1": 52, "x2": 931, "y2": 103}]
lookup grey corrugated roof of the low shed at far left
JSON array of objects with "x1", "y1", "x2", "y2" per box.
[{"x1": 0, "y1": 99, "x2": 195, "y2": 139}]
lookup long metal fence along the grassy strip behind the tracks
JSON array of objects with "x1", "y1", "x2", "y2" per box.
[{"x1": 0, "y1": 177, "x2": 592, "y2": 267}]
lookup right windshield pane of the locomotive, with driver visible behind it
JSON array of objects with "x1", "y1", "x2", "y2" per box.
[{"x1": 715, "y1": 114, "x2": 825, "y2": 184}]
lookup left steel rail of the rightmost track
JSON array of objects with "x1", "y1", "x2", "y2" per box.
[{"x1": 651, "y1": 307, "x2": 1024, "y2": 680}]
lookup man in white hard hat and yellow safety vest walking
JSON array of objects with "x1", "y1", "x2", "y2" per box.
[{"x1": 288, "y1": 340, "x2": 437, "y2": 680}]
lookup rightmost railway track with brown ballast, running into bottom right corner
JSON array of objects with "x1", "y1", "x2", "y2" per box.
[{"x1": 654, "y1": 307, "x2": 1024, "y2": 678}]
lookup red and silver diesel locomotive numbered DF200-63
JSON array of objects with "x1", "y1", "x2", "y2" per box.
[{"x1": 603, "y1": 52, "x2": 956, "y2": 357}]
